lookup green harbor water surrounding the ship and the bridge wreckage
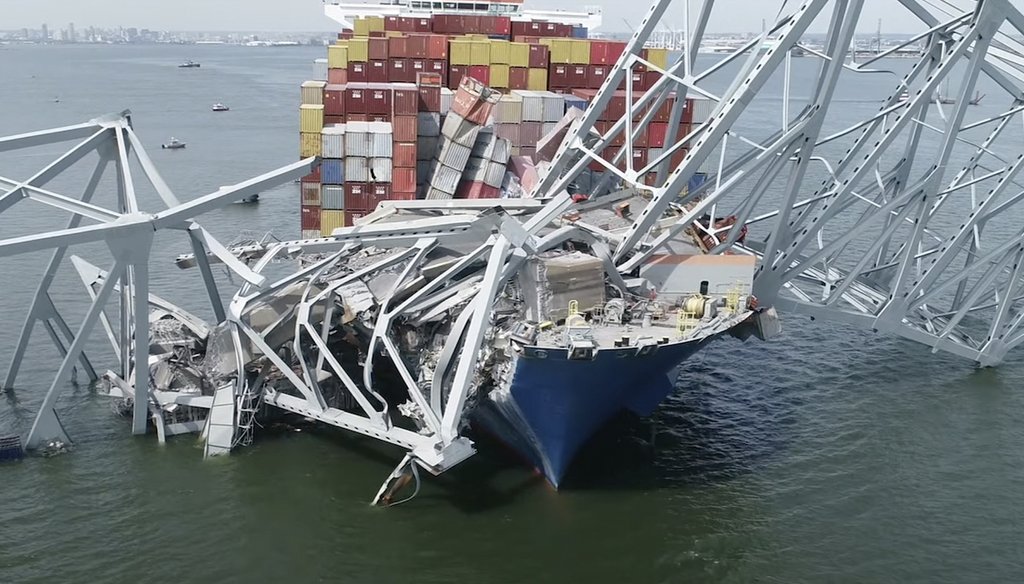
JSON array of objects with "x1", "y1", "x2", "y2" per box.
[{"x1": 0, "y1": 46, "x2": 1024, "y2": 584}]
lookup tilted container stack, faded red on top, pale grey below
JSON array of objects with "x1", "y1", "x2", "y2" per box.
[{"x1": 425, "y1": 78, "x2": 501, "y2": 199}]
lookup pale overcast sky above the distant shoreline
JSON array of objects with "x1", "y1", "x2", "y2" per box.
[{"x1": 8, "y1": 0, "x2": 1024, "y2": 33}]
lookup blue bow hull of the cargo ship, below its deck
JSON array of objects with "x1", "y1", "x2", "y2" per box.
[{"x1": 475, "y1": 335, "x2": 717, "y2": 488}]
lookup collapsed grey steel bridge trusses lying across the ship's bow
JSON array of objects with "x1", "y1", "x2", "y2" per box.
[{"x1": 6, "y1": 0, "x2": 1024, "y2": 501}]
